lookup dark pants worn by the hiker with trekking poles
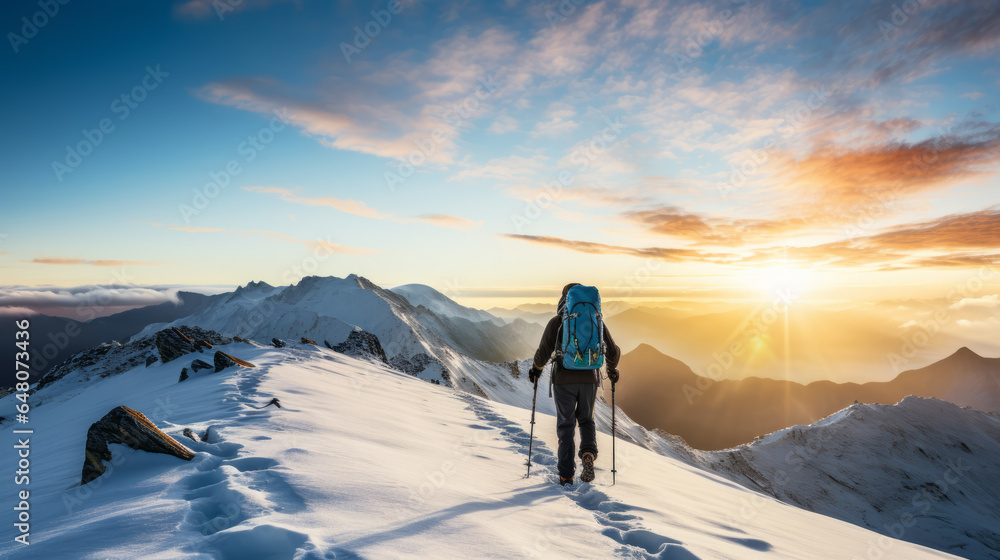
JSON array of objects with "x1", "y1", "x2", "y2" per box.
[{"x1": 553, "y1": 383, "x2": 597, "y2": 478}]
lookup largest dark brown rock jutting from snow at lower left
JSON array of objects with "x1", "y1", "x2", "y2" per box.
[{"x1": 80, "y1": 406, "x2": 194, "y2": 484}]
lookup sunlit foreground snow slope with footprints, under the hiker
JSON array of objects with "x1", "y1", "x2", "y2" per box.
[{"x1": 0, "y1": 343, "x2": 968, "y2": 560}]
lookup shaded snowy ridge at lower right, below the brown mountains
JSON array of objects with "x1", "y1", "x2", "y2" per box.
[{"x1": 668, "y1": 397, "x2": 1000, "y2": 559}]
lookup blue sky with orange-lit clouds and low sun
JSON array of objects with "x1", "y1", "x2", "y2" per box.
[{"x1": 0, "y1": 0, "x2": 1000, "y2": 308}]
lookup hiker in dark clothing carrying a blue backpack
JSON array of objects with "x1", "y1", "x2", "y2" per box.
[{"x1": 528, "y1": 283, "x2": 621, "y2": 486}]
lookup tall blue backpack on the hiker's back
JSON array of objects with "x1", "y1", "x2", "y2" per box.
[{"x1": 559, "y1": 286, "x2": 604, "y2": 370}]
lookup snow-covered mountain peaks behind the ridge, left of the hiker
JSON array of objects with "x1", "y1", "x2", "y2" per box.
[{"x1": 137, "y1": 274, "x2": 541, "y2": 380}]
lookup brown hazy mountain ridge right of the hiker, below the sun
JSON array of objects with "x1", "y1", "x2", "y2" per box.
[{"x1": 606, "y1": 345, "x2": 1000, "y2": 449}]
